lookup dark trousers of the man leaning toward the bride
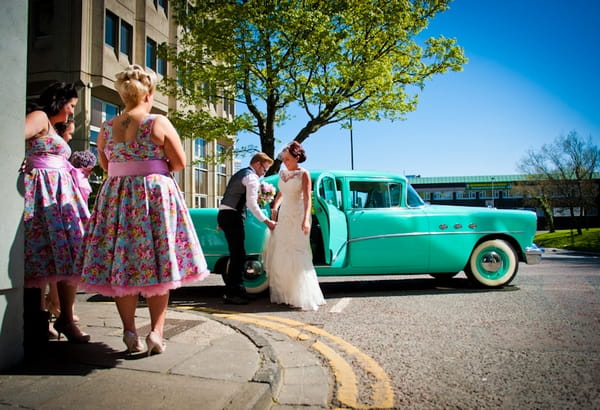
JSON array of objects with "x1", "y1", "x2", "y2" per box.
[{"x1": 217, "y1": 209, "x2": 246, "y2": 297}]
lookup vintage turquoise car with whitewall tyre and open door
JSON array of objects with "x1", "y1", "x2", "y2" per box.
[{"x1": 190, "y1": 171, "x2": 543, "y2": 293}]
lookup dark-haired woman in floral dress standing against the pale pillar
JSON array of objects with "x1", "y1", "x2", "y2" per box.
[{"x1": 23, "y1": 83, "x2": 90, "y2": 343}]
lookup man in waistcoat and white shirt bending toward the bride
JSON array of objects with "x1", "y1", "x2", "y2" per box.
[{"x1": 217, "y1": 152, "x2": 275, "y2": 305}]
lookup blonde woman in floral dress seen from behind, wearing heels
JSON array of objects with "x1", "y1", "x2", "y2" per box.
[{"x1": 81, "y1": 65, "x2": 209, "y2": 354}]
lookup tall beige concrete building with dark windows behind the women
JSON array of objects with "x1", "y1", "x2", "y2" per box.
[{"x1": 27, "y1": 0, "x2": 235, "y2": 207}]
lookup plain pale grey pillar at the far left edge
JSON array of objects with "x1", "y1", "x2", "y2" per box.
[{"x1": 0, "y1": 0, "x2": 28, "y2": 370}]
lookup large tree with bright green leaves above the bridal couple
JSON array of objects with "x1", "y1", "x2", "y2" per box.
[{"x1": 161, "y1": 0, "x2": 467, "y2": 172}]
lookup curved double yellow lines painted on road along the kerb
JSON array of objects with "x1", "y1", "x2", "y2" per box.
[{"x1": 178, "y1": 306, "x2": 394, "y2": 409}]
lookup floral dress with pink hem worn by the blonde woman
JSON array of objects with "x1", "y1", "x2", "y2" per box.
[{"x1": 80, "y1": 115, "x2": 209, "y2": 297}]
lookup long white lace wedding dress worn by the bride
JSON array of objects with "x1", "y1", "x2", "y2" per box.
[{"x1": 263, "y1": 169, "x2": 325, "y2": 310}]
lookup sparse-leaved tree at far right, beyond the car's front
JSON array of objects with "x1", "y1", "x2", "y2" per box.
[{"x1": 518, "y1": 131, "x2": 600, "y2": 235}]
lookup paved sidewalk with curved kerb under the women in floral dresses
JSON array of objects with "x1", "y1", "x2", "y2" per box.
[{"x1": 0, "y1": 295, "x2": 332, "y2": 410}]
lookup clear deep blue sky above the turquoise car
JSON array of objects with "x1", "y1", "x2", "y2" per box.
[{"x1": 240, "y1": 0, "x2": 600, "y2": 176}]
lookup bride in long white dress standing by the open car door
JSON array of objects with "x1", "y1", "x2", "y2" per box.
[{"x1": 264, "y1": 141, "x2": 325, "y2": 310}]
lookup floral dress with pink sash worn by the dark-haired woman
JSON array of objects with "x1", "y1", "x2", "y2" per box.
[{"x1": 23, "y1": 123, "x2": 90, "y2": 288}]
